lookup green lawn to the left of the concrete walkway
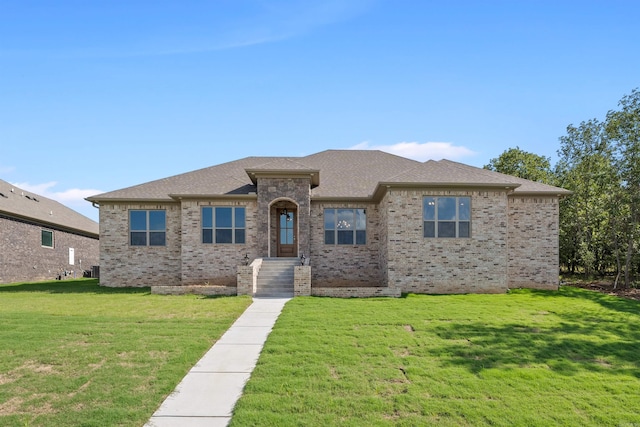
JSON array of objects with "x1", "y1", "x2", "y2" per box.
[{"x1": 0, "y1": 279, "x2": 251, "y2": 427}]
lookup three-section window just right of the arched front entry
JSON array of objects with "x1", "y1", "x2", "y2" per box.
[{"x1": 324, "y1": 209, "x2": 367, "y2": 245}]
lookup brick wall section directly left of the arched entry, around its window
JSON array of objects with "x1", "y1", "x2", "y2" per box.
[{"x1": 181, "y1": 200, "x2": 258, "y2": 286}]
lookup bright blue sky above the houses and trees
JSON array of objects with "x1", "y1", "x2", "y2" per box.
[{"x1": 0, "y1": 0, "x2": 640, "y2": 220}]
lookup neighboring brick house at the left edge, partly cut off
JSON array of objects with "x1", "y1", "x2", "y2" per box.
[{"x1": 0, "y1": 180, "x2": 99, "y2": 283}]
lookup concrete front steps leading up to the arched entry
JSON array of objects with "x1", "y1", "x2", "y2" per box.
[{"x1": 253, "y1": 258, "x2": 300, "y2": 298}]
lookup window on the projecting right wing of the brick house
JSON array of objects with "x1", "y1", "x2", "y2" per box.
[{"x1": 422, "y1": 197, "x2": 471, "y2": 237}]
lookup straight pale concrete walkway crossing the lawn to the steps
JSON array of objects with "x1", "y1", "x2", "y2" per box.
[{"x1": 145, "y1": 298, "x2": 290, "y2": 427}]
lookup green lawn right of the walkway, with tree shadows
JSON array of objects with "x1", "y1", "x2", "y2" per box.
[{"x1": 232, "y1": 287, "x2": 640, "y2": 427}]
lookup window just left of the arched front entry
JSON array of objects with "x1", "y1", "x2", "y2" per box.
[{"x1": 202, "y1": 206, "x2": 245, "y2": 244}]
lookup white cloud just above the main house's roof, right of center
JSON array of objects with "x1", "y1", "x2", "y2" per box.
[{"x1": 350, "y1": 141, "x2": 476, "y2": 162}]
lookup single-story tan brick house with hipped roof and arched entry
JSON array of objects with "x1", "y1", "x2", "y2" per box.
[{"x1": 87, "y1": 150, "x2": 569, "y2": 297}]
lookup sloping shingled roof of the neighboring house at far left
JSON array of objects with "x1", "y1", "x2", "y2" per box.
[{"x1": 0, "y1": 179, "x2": 99, "y2": 238}]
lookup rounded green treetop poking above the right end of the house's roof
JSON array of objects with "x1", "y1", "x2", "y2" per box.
[{"x1": 484, "y1": 147, "x2": 554, "y2": 184}]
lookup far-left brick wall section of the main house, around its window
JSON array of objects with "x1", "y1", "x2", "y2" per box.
[{"x1": 100, "y1": 202, "x2": 182, "y2": 287}]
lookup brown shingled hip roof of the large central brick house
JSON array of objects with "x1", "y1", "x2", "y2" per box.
[{"x1": 87, "y1": 150, "x2": 570, "y2": 202}]
